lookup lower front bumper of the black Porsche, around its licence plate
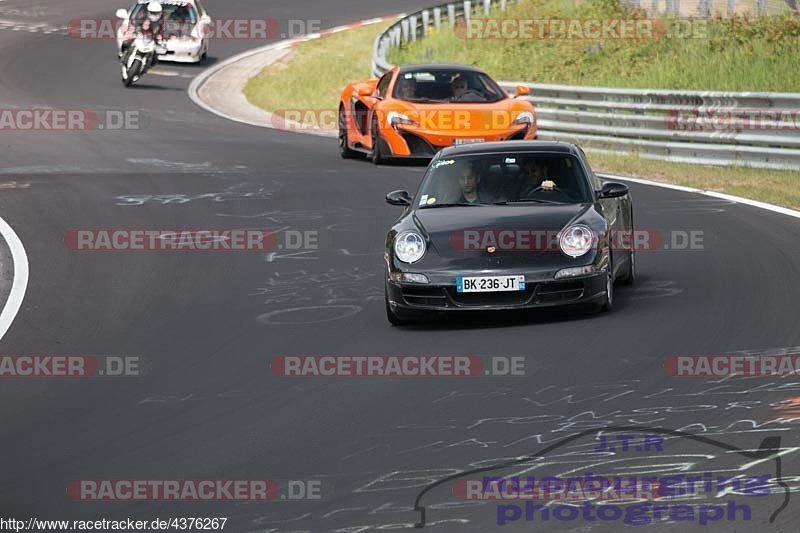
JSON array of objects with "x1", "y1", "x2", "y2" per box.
[{"x1": 386, "y1": 271, "x2": 606, "y2": 315}]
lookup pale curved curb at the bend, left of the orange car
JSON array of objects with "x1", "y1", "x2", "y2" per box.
[{"x1": 187, "y1": 13, "x2": 405, "y2": 137}]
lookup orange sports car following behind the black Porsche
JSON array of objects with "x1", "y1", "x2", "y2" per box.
[{"x1": 339, "y1": 65, "x2": 536, "y2": 164}]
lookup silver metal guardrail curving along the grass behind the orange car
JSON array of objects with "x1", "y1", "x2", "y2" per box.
[{"x1": 372, "y1": 0, "x2": 800, "y2": 170}]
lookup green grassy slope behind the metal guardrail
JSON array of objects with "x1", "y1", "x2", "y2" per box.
[{"x1": 388, "y1": 0, "x2": 800, "y2": 92}]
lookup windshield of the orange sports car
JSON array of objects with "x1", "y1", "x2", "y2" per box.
[{"x1": 392, "y1": 69, "x2": 506, "y2": 103}]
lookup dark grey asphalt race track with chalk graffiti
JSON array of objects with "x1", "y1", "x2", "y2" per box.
[{"x1": 0, "y1": 0, "x2": 800, "y2": 532}]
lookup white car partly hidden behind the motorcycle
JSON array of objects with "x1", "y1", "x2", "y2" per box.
[{"x1": 117, "y1": 0, "x2": 211, "y2": 63}]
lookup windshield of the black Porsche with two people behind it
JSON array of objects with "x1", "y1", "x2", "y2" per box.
[{"x1": 416, "y1": 153, "x2": 592, "y2": 209}]
